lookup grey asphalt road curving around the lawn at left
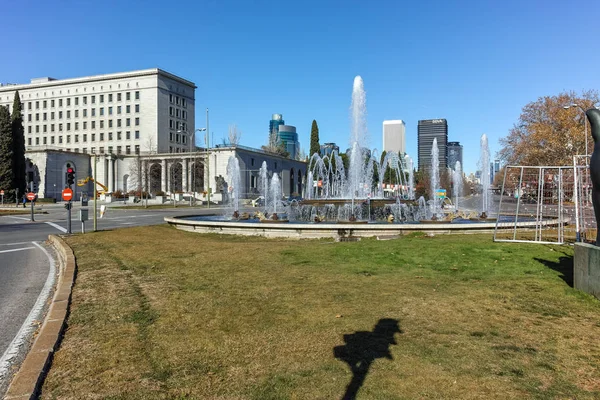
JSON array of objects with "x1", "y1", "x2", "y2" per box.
[{"x1": 0, "y1": 204, "x2": 220, "y2": 390}]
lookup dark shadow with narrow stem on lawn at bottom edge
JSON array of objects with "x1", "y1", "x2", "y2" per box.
[{"x1": 333, "y1": 318, "x2": 402, "y2": 400}]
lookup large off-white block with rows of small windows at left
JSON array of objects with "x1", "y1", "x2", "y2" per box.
[{"x1": 0, "y1": 68, "x2": 196, "y2": 155}]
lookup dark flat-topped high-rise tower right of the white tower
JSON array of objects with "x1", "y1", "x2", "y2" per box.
[{"x1": 417, "y1": 119, "x2": 448, "y2": 171}]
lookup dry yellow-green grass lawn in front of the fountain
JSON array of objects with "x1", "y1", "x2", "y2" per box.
[{"x1": 42, "y1": 225, "x2": 600, "y2": 400}]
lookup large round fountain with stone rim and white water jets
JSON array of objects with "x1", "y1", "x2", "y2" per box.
[{"x1": 165, "y1": 76, "x2": 552, "y2": 238}]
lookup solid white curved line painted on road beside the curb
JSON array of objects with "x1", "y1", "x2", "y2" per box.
[{"x1": 0, "y1": 242, "x2": 56, "y2": 380}]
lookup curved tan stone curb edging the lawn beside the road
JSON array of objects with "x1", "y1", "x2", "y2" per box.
[{"x1": 5, "y1": 235, "x2": 76, "y2": 400}]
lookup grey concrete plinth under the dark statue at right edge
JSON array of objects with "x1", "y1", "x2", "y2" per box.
[{"x1": 573, "y1": 243, "x2": 600, "y2": 299}]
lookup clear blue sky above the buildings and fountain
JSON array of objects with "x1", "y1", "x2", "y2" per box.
[{"x1": 0, "y1": 0, "x2": 600, "y2": 172}]
